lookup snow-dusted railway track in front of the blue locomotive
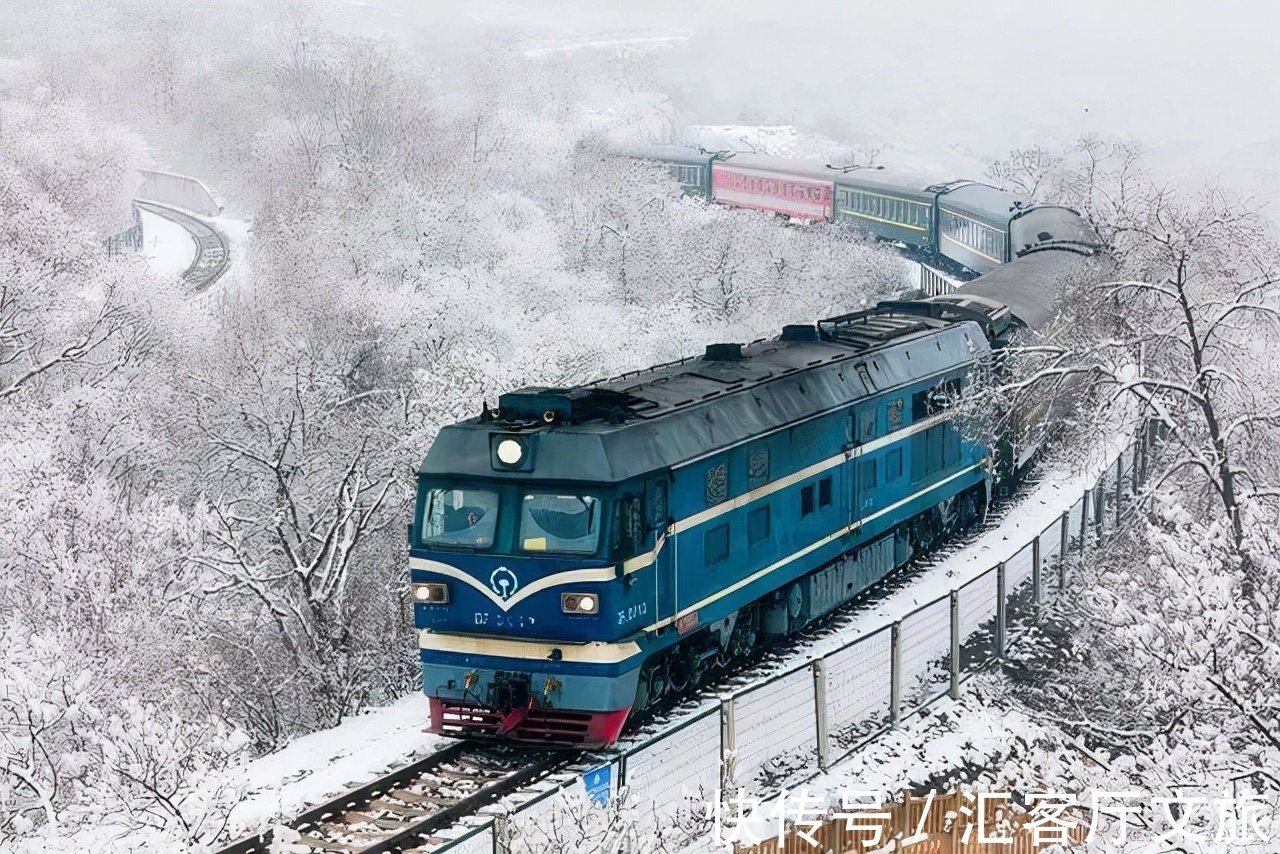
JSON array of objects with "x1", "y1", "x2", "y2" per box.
[{"x1": 216, "y1": 741, "x2": 579, "y2": 854}]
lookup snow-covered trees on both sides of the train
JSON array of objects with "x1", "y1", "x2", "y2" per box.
[{"x1": 0, "y1": 3, "x2": 1280, "y2": 851}]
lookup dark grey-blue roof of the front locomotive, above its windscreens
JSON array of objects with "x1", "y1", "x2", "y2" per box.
[{"x1": 420, "y1": 310, "x2": 987, "y2": 483}]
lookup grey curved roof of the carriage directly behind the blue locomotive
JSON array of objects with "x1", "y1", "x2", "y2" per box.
[{"x1": 955, "y1": 248, "x2": 1111, "y2": 332}]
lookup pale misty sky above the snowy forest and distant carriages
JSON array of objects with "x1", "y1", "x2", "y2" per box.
[{"x1": 322, "y1": 0, "x2": 1280, "y2": 179}]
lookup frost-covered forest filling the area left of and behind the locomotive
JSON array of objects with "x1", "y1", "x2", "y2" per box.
[{"x1": 0, "y1": 4, "x2": 908, "y2": 850}]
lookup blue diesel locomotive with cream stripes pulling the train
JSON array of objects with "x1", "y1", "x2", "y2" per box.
[{"x1": 410, "y1": 243, "x2": 1093, "y2": 746}]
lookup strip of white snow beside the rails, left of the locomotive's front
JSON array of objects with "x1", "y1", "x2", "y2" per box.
[{"x1": 228, "y1": 693, "x2": 451, "y2": 836}]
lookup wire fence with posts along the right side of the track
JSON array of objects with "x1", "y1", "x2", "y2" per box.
[{"x1": 436, "y1": 428, "x2": 1151, "y2": 854}]
